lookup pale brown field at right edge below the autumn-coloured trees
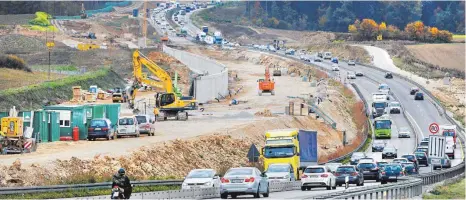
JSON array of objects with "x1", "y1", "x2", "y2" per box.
[{"x1": 406, "y1": 43, "x2": 466, "y2": 72}]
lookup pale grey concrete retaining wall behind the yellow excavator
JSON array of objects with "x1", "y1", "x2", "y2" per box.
[{"x1": 163, "y1": 46, "x2": 228, "y2": 103}]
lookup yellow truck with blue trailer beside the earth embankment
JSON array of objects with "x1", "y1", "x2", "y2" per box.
[{"x1": 261, "y1": 129, "x2": 317, "y2": 180}]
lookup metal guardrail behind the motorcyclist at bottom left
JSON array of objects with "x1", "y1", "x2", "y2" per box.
[{"x1": 0, "y1": 180, "x2": 183, "y2": 195}]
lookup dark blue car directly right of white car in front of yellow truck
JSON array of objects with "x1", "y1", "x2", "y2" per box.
[{"x1": 333, "y1": 165, "x2": 364, "y2": 186}]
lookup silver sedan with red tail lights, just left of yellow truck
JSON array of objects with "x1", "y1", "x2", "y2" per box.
[{"x1": 220, "y1": 167, "x2": 269, "y2": 199}]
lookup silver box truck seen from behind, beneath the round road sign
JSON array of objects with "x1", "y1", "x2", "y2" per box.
[{"x1": 427, "y1": 135, "x2": 446, "y2": 171}]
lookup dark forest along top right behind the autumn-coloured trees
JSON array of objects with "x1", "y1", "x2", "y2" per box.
[{"x1": 238, "y1": 1, "x2": 465, "y2": 34}]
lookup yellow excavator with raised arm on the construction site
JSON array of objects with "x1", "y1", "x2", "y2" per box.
[{"x1": 130, "y1": 50, "x2": 197, "y2": 121}]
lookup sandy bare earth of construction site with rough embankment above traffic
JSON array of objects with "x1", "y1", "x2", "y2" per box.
[{"x1": 0, "y1": 49, "x2": 356, "y2": 186}]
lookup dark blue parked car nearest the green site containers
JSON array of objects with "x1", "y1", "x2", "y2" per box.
[{"x1": 87, "y1": 118, "x2": 115, "y2": 140}]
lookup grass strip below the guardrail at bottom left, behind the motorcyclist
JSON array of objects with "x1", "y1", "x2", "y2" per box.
[{"x1": 0, "y1": 185, "x2": 180, "y2": 199}]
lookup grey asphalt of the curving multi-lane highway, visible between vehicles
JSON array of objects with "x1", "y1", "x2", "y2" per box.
[{"x1": 122, "y1": 4, "x2": 463, "y2": 199}]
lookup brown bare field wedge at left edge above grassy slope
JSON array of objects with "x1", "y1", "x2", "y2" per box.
[{"x1": 0, "y1": 68, "x2": 66, "y2": 90}]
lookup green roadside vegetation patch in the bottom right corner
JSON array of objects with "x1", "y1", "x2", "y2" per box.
[{"x1": 422, "y1": 178, "x2": 465, "y2": 199}]
